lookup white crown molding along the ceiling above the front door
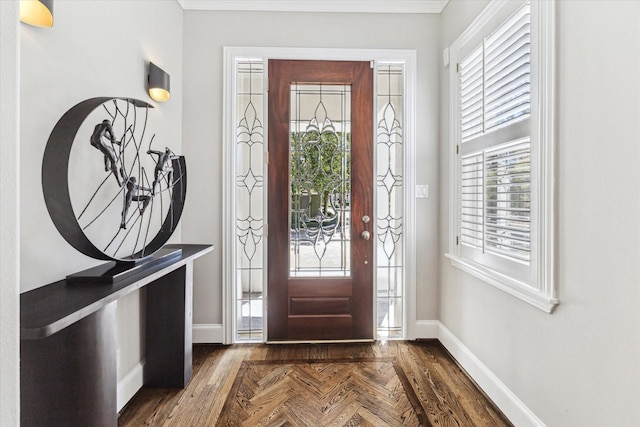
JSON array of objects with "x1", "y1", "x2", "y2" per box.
[{"x1": 176, "y1": 0, "x2": 449, "y2": 14}]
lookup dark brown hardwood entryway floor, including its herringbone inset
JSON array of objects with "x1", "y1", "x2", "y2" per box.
[{"x1": 118, "y1": 341, "x2": 512, "y2": 427}]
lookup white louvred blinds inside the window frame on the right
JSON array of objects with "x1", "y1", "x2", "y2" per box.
[{"x1": 458, "y1": 3, "x2": 531, "y2": 264}]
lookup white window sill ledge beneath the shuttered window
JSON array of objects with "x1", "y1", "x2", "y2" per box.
[{"x1": 445, "y1": 254, "x2": 559, "y2": 313}]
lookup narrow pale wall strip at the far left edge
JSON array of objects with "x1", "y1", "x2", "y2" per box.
[{"x1": 0, "y1": 1, "x2": 20, "y2": 427}]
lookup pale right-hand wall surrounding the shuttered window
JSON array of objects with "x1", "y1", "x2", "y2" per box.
[{"x1": 440, "y1": 0, "x2": 640, "y2": 427}]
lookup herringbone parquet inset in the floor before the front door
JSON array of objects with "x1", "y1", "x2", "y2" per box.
[{"x1": 217, "y1": 357, "x2": 427, "y2": 426}]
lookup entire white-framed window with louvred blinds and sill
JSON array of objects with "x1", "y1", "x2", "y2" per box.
[{"x1": 447, "y1": 0, "x2": 557, "y2": 311}]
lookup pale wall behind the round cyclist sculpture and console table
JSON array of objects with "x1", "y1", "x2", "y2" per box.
[{"x1": 19, "y1": 0, "x2": 183, "y2": 402}]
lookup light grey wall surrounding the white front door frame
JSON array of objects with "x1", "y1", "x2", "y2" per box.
[{"x1": 183, "y1": 11, "x2": 440, "y2": 332}]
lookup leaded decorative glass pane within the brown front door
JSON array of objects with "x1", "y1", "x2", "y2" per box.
[{"x1": 289, "y1": 84, "x2": 351, "y2": 277}]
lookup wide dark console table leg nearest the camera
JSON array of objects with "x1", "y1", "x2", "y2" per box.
[{"x1": 20, "y1": 303, "x2": 118, "y2": 427}]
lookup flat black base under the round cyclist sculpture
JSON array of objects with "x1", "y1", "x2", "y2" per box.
[{"x1": 65, "y1": 248, "x2": 182, "y2": 285}]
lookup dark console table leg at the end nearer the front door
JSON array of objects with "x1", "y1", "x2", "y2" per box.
[{"x1": 144, "y1": 262, "x2": 193, "y2": 388}]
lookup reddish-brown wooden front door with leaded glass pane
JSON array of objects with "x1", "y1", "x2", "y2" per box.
[{"x1": 267, "y1": 60, "x2": 374, "y2": 341}]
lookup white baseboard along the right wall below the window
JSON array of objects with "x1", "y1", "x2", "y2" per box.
[{"x1": 436, "y1": 321, "x2": 545, "y2": 427}]
